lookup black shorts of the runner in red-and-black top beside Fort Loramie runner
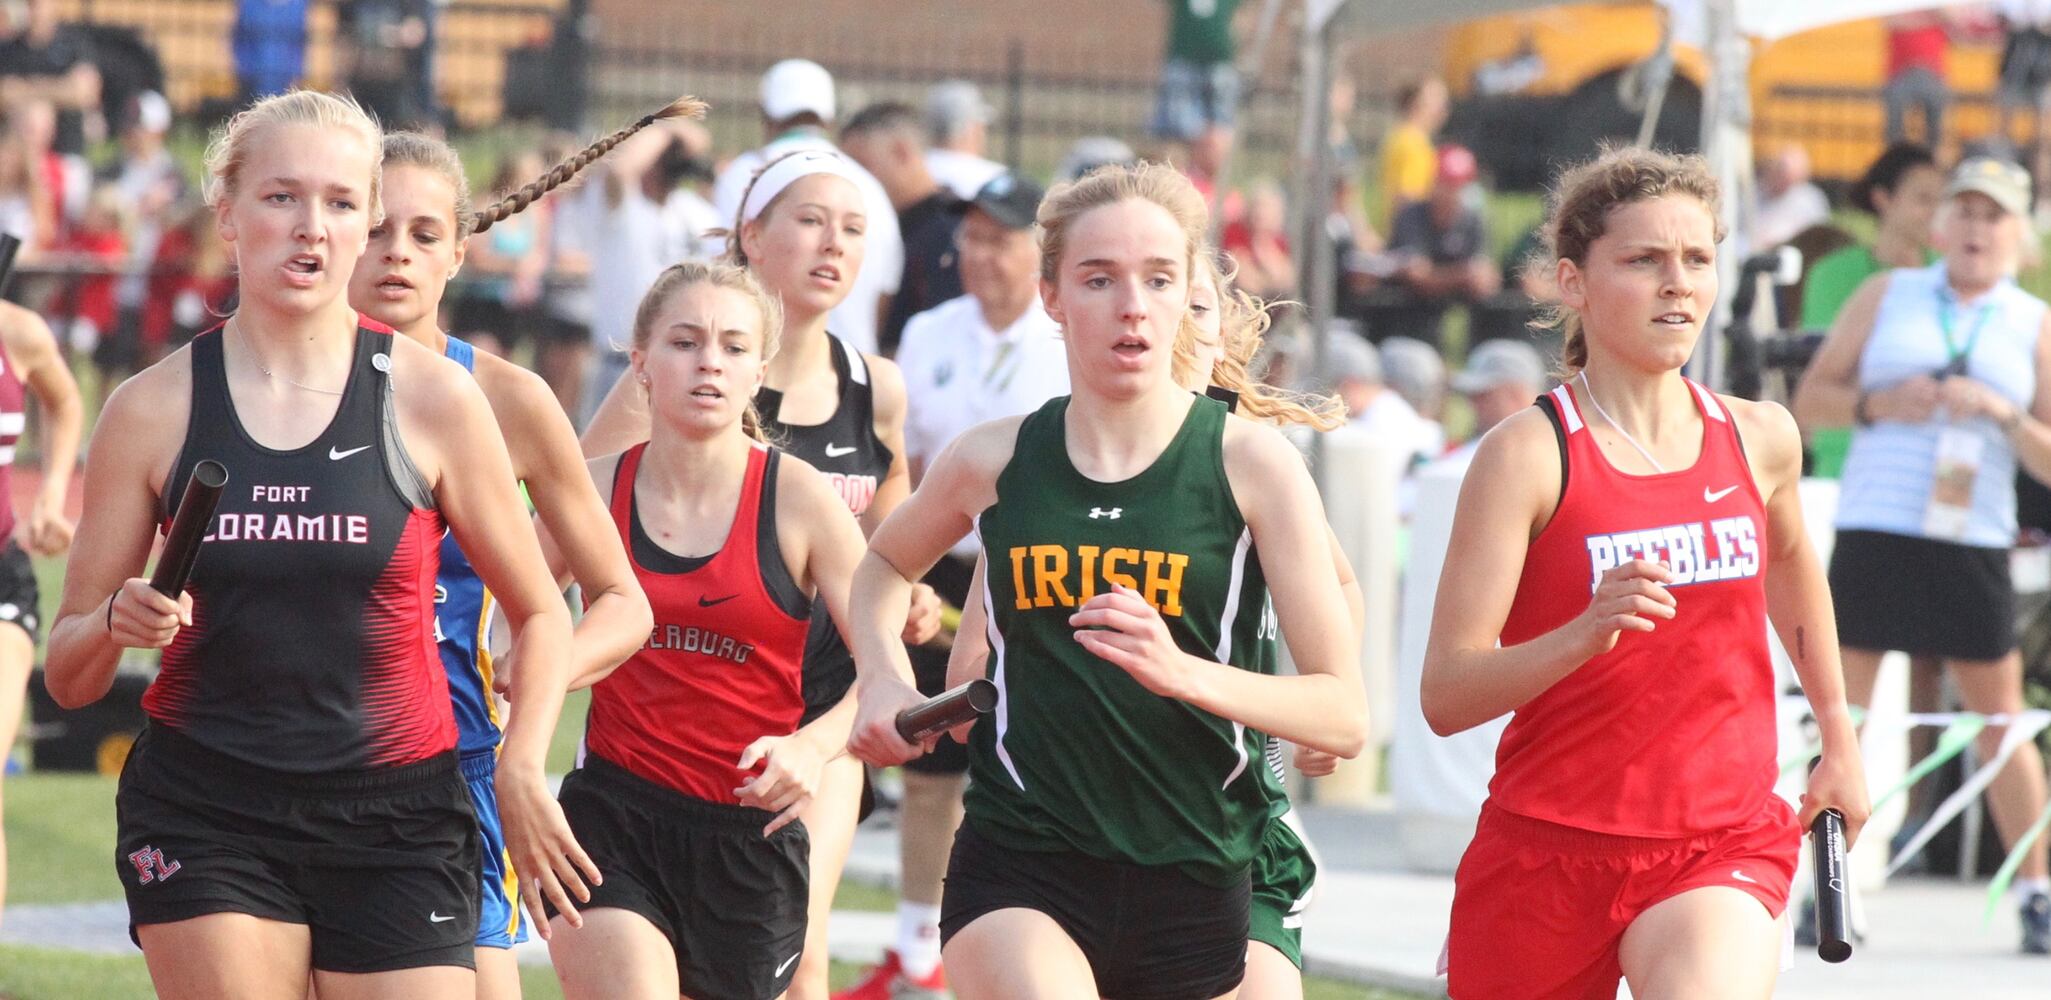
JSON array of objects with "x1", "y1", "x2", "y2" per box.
[{"x1": 550, "y1": 754, "x2": 812, "y2": 1000}]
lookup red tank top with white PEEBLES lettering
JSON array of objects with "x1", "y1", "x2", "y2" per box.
[{"x1": 1489, "y1": 381, "x2": 1778, "y2": 838}]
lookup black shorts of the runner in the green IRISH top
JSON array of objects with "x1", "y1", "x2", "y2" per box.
[{"x1": 939, "y1": 824, "x2": 1251, "y2": 1000}]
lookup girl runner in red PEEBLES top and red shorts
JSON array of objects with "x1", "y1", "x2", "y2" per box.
[{"x1": 1421, "y1": 150, "x2": 1868, "y2": 1000}]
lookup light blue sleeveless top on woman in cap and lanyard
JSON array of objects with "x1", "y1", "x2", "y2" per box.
[{"x1": 1838, "y1": 260, "x2": 2045, "y2": 549}]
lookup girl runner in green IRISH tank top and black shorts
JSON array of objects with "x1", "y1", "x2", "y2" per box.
[{"x1": 849, "y1": 166, "x2": 1366, "y2": 1000}]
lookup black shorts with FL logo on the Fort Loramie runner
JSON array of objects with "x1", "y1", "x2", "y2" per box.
[{"x1": 115, "y1": 723, "x2": 482, "y2": 973}]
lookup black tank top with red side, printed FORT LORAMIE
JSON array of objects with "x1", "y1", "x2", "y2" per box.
[{"x1": 144, "y1": 326, "x2": 455, "y2": 773}]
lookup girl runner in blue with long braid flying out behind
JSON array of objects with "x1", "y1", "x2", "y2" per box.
[{"x1": 349, "y1": 115, "x2": 687, "y2": 1000}]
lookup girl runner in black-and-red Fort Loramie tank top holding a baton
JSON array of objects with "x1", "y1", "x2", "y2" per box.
[{"x1": 49, "y1": 92, "x2": 597, "y2": 1000}]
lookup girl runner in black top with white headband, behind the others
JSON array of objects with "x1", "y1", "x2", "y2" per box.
[{"x1": 582, "y1": 150, "x2": 939, "y2": 1000}]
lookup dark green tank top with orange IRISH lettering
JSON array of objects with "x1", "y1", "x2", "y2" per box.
[{"x1": 966, "y1": 395, "x2": 1276, "y2": 885}]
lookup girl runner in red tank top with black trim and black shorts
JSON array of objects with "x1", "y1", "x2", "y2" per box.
[{"x1": 544, "y1": 262, "x2": 861, "y2": 1000}]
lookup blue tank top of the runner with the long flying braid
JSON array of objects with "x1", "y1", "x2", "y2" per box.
[{"x1": 435, "y1": 336, "x2": 505, "y2": 756}]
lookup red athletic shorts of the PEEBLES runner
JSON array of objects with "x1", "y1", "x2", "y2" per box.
[{"x1": 1446, "y1": 797, "x2": 1801, "y2": 1000}]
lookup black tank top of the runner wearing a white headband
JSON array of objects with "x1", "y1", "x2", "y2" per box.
[{"x1": 755, "y1": 334, "x2": 894, "y2": 721}]
